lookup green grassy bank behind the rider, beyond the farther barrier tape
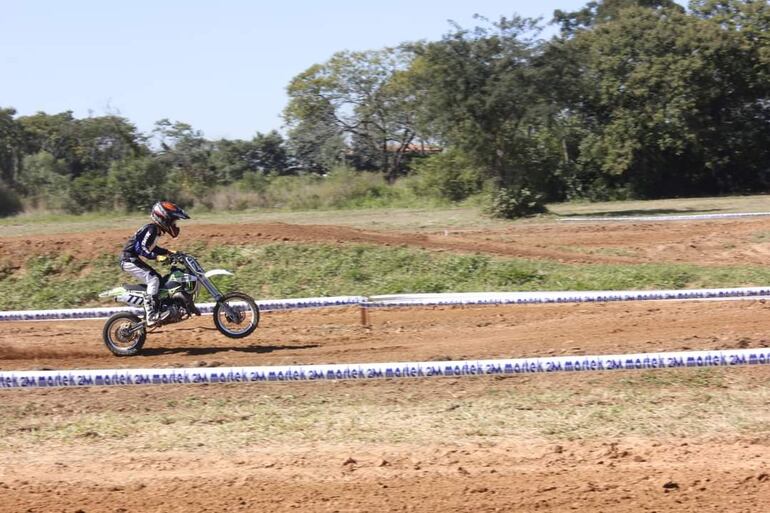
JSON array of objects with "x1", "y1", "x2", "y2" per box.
[{"x1": 0, "y1": 244, "x2": 770, "y2": 310}]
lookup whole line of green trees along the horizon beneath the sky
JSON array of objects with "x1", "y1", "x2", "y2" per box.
[{"x1": 0, "y1": 0, "x2": 770, "y2": 217}]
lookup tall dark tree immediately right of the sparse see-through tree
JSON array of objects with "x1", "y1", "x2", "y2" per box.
[{"x1": 414, "y1": 17, "x2": 551, "y2": 216}]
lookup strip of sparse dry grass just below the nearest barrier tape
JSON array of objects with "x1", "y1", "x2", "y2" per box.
[{"x1": 6, "y1": 369, "x2": 770, "y2": 451}]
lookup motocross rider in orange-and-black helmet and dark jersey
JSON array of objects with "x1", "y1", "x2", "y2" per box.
[{"x1": 120, "y1": 201, "x2": 190, "y2": 326}]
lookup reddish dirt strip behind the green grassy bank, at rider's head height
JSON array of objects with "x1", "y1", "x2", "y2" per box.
[{"x1": 0, "y1": 218, "x2": 770, "y2": 265}]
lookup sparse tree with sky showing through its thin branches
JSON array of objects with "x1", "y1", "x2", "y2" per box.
[{"x1": 284, "y1": 48, "x2": 424, "y2": 181}]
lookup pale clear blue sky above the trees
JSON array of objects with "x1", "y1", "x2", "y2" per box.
[{"x1": 0, "y1": 0, "x2": 587, "y2": 139}]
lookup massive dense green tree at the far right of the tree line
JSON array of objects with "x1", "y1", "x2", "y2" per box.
[{"x1": 575, "y1": 3, "x2": 770, "y2": 197}]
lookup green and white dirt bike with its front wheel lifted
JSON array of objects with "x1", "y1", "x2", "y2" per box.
[{"x1": 99, "y1": 253, "x2": 259, "y2": 356}]
